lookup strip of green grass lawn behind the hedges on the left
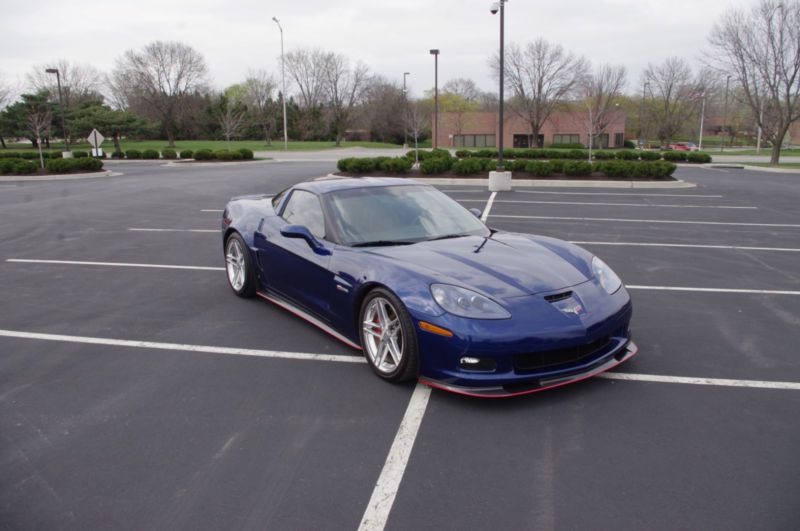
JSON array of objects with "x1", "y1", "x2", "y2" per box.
[{"x1": 3, "y1": 140, "x2": 402, "y2": 153}]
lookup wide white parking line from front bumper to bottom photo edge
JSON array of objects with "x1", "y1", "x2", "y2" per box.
[{"x1": 358, "y1": 383, "x2": 431, "y2": 531}]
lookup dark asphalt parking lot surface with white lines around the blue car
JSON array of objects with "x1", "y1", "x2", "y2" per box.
[{"x1": 0, "y1": 161, "x2": 800, "y2": 529}]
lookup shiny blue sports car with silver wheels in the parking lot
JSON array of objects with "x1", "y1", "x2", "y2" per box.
[{"x1": 222, "y1": 178, "x2": 638, "y2": 397}]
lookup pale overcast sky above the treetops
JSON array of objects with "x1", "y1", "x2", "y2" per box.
[{"x1": 0, "y1": 0, "x2": 754, "y2": 95}]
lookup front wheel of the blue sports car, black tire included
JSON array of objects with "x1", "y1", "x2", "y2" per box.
[{"x1": 358, "y1": 288, "x2": 419, "y2": 382}]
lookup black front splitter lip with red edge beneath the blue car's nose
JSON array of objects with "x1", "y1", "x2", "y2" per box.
[{"x1": 419, "y1": 340, "x2": 639, "y2": 398}]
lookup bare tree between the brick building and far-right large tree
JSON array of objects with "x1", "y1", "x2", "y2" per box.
[{"x1": 644, "y1": 57, "x2": 707, "y2": 145}]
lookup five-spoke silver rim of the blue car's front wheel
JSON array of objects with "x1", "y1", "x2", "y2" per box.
[{"x1": 361, "y1": 297, "x2": 403, "y2": 374}]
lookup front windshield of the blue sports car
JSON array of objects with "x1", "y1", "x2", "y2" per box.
[{"x1": 325, "y1": 185, "x2": 490, "y2": 246}]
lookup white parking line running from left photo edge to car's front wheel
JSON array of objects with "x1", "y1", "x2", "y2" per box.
[{"x1": 0, "y1": 330, "x2": 366, "y2": 363}]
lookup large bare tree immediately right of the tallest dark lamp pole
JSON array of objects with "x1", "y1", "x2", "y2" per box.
[{"x1": 490, "y1": 39, "x2": 588, "y2": 147}]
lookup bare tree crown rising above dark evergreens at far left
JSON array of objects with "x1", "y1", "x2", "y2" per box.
[{"x1": 26, "y1": 59, "x2": 103, "y2": 109}]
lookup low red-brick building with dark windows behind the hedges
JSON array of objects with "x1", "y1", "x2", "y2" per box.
[{"x1": 432, "y1": 110, "x2": 626, "y2": 149}]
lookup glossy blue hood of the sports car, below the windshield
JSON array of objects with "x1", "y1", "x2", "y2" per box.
[{"x1": 369, "y1": 233, "x2": 590, "y2": 299}]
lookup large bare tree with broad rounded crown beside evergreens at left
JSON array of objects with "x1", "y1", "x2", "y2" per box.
[{"x1": 111, "y1": 41, "x2": 208, "y2": 147}]
